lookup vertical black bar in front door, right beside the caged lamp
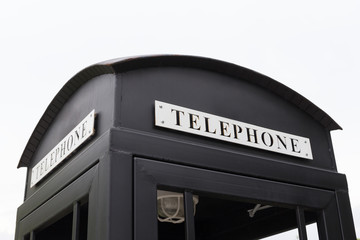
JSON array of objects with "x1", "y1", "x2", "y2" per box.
[{"x1": 184, "y1": 191, "x2": 195, "y2": 240}]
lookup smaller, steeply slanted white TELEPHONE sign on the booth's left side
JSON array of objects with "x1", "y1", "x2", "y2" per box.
[{"x1": 30, "y1": 110, "x2": 95, "y2": 187}]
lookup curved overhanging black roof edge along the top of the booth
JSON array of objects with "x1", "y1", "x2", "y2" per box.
[{"x1": 18, "y1": 55, "x2": 341, "y2": 168}]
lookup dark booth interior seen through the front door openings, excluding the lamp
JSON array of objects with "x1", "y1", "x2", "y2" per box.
[{"x1": 158, "y1": 196, "x2": 317, "y2": 240}]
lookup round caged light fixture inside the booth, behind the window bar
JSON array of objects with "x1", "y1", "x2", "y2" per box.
[{"x1": 157, "y1": 190, "x2": 199, "y2": 223}]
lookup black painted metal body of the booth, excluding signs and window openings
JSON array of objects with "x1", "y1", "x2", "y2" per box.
[{"x1": 16, "y1": 55, "x2": 355, "y2": 239}]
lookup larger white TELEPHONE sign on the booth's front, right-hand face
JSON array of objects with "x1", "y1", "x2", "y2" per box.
[{"x1": 155, "y1": 101, "x2": 313, "y2": 159}]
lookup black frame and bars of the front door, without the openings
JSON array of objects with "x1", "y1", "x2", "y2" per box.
[{"x1": 134, "y1": 157, "x2": 343, "y2": 240}]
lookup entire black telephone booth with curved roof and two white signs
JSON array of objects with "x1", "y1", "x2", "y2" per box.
[{"x1": 15, "y1": 55, "x2": 355, "y2": 240}]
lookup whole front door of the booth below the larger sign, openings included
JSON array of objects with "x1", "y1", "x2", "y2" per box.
[{"x1": 134, "y1": 158, "x2": 343, "y2": 240}]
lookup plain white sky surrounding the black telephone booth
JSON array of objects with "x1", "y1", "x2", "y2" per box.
[{"x1": 0, "y1": 0, "x2": 360, "y2": 240}]
